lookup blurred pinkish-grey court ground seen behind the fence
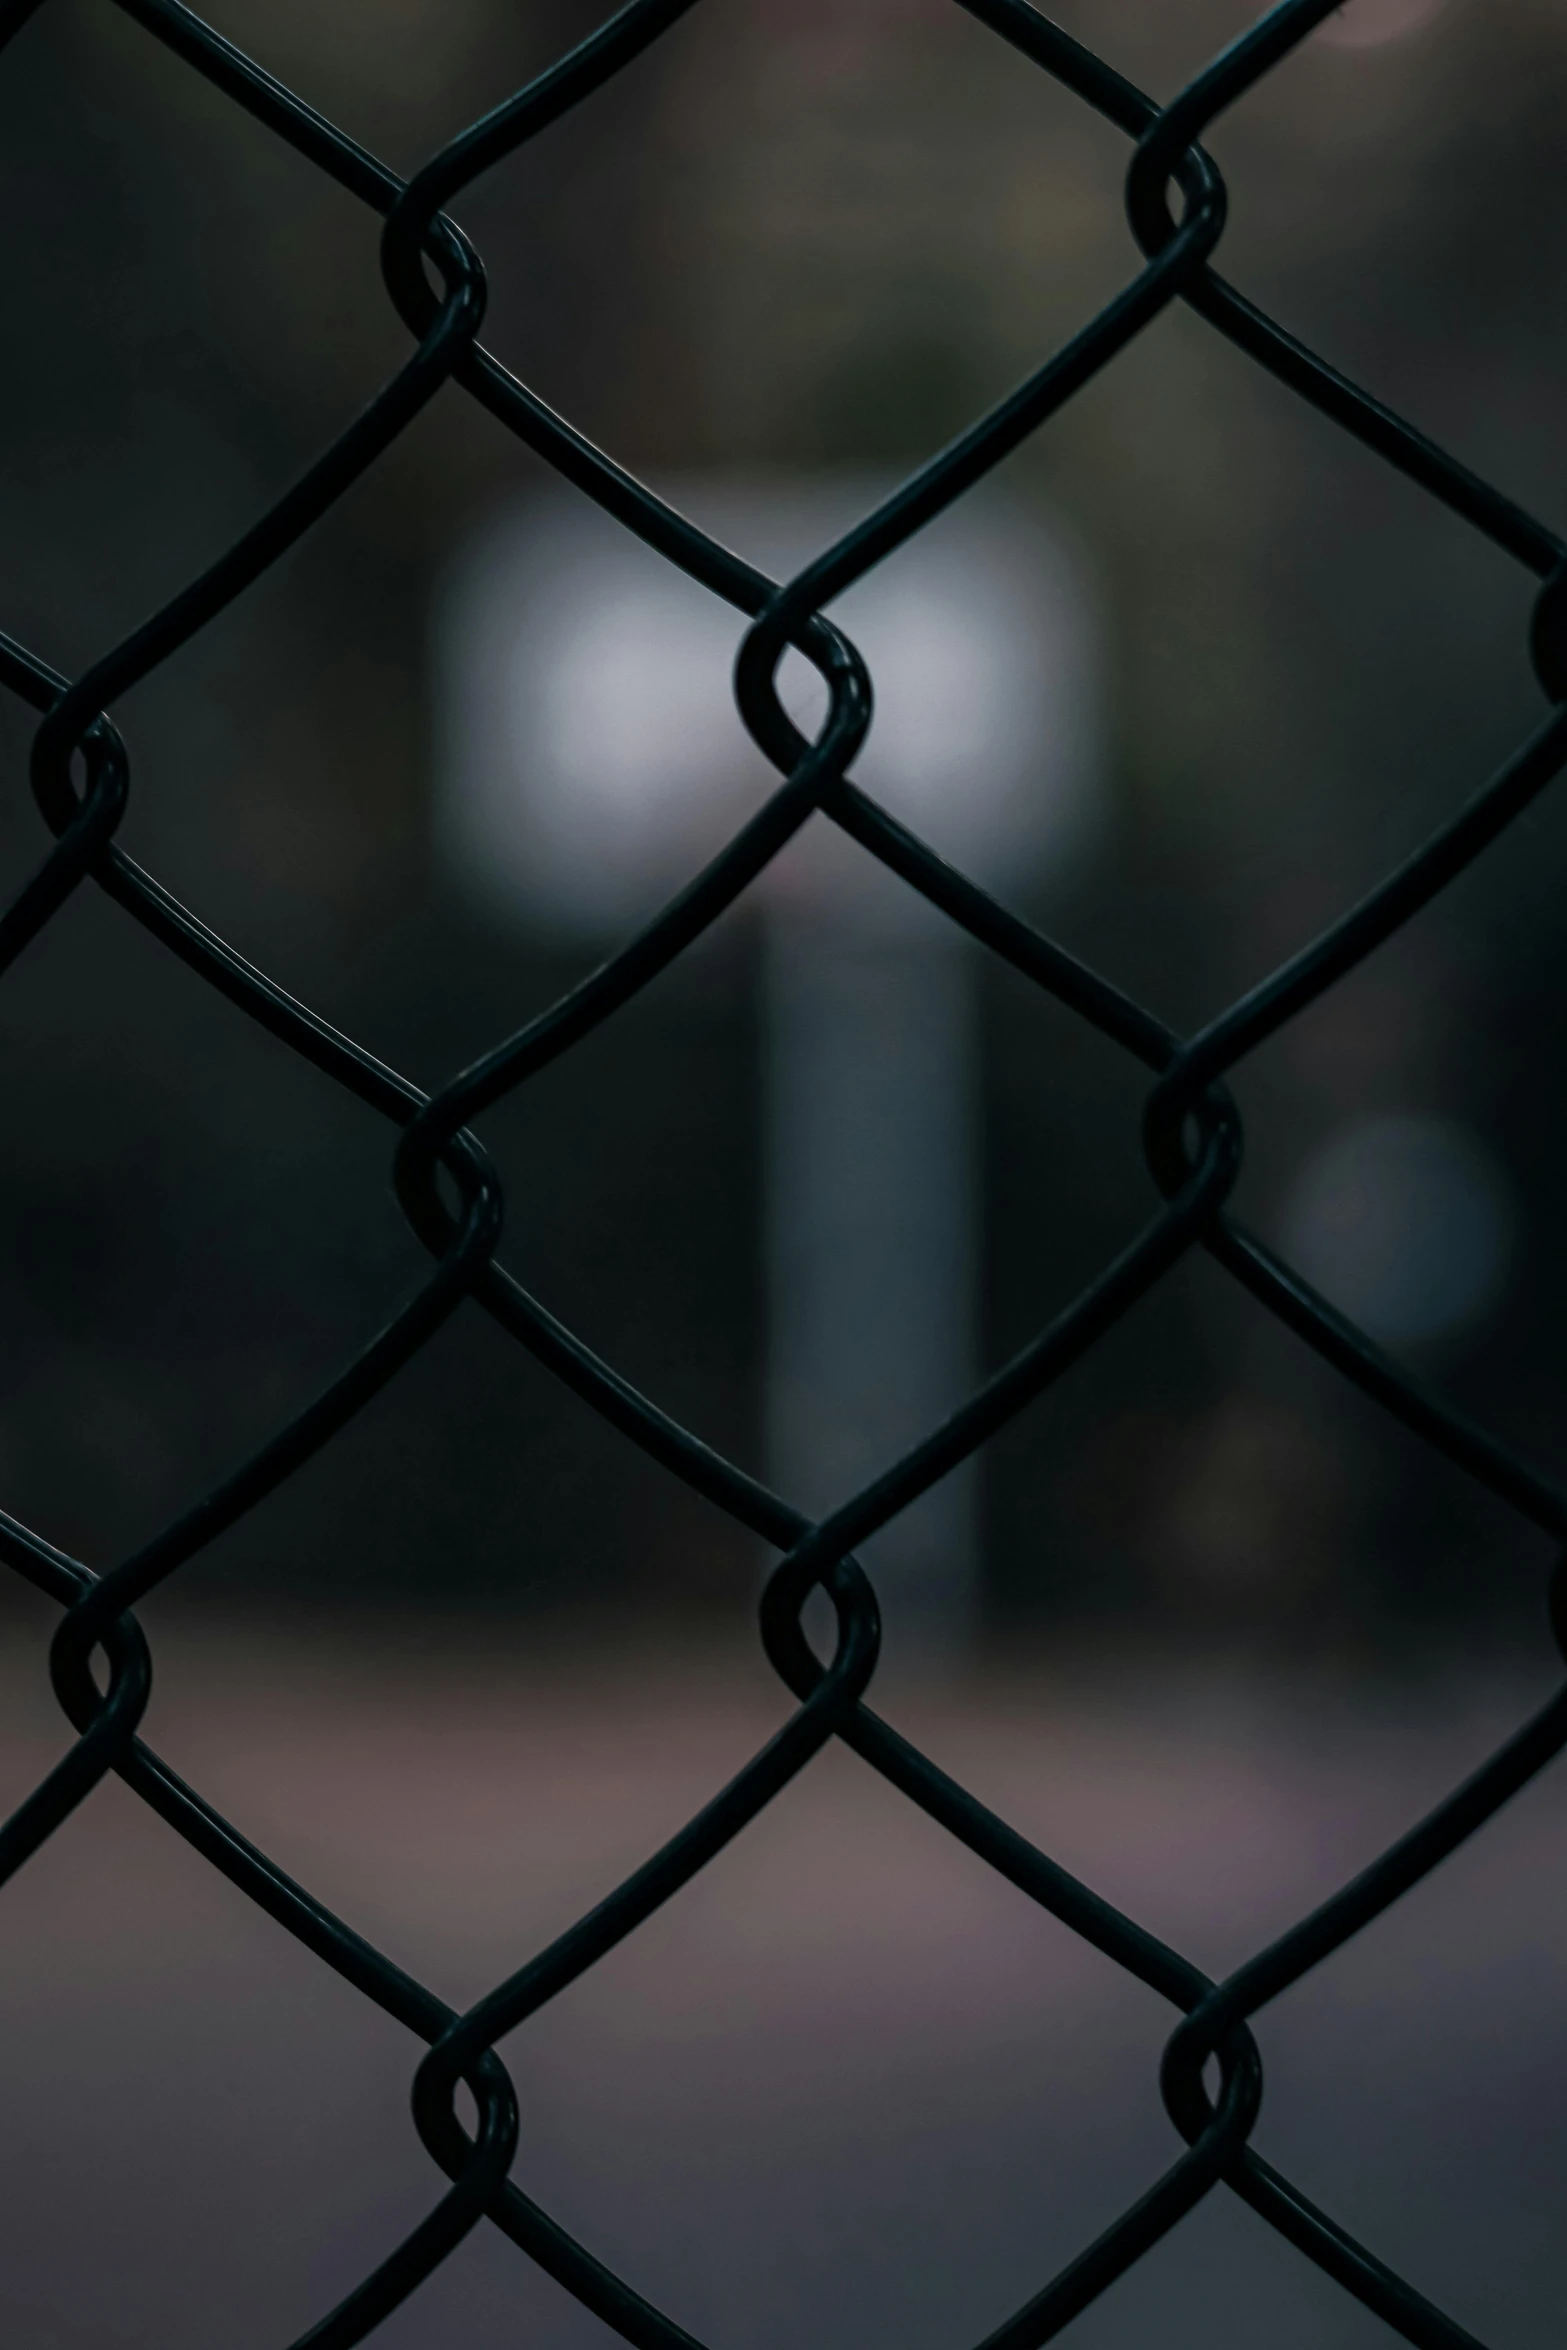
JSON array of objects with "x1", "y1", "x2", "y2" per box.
[{"x1": 0, "y1": 1629, "x2": 1567, "y2": 2350}]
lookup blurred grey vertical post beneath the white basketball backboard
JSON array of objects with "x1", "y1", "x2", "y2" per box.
[{"x1": 764, "y1": 898, "x2": 982, "y2": 1636}]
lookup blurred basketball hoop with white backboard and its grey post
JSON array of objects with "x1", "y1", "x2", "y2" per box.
[{"x1": 439, "y1": 477, "x2": 1095, "y2": 1636}]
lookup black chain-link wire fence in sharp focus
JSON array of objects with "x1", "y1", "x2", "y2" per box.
[{"x1": 0, "y1": 0, "x2": 1567, "y2": 2350}]
